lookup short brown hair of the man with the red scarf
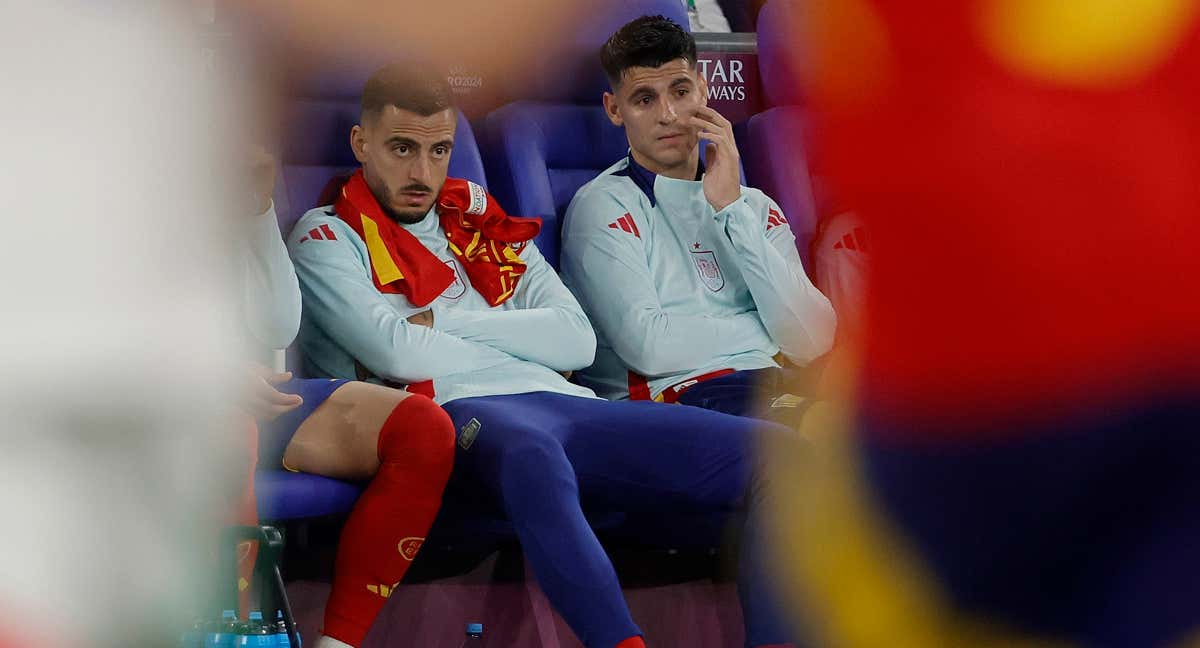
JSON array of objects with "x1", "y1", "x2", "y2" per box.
[{"x1": 359, "y1": 62, "x2": 454, "y2": 121}]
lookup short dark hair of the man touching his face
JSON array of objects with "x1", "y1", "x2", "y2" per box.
[{"x1": 600, "y1": 16, "x2": 696, "y2": 88}]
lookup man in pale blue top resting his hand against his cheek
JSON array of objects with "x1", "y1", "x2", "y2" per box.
[{"x1": 562, "y1": 16, "x2": 836, "y2": 415}]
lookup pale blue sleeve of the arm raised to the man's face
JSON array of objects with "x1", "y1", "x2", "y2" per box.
[{"x1": 715, "y1": 193, "x2": 838, "y2": 366}]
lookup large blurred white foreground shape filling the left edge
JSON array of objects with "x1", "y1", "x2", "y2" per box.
[{"x1": 0, "y1": 2, "x2": 241, "y2": 646}]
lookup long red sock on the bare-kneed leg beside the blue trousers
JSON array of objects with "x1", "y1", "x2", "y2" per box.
[{"x1": 323, "y1": 395, "x2": 455, "y2": 646}]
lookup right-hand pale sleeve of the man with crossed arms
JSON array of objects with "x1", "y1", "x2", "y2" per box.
[{"x1": 433, "y1": 241, "x2": 596, "y2": 371}]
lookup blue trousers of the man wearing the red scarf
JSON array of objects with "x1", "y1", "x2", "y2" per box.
[{"x1": 444, "y1": 392, "x2": 791, "y2": 648}]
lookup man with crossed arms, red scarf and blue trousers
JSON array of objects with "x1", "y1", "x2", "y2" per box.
[{"x1": 289, "y1": 65, "x2": 801, "y2": 648}]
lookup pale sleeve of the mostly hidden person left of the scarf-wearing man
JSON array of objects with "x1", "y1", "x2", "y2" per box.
[{"x1": 241, "y1": 203, "x2": 300, "y2": 349}]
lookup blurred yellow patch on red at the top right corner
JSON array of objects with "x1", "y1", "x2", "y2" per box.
[{"x1": 978, "y1": 0, "x2": 1198, "y2": 86}]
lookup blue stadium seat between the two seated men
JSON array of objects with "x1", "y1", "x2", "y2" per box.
[{"x1": 481, "y1": 0, "x2": 688, "y2": 268}]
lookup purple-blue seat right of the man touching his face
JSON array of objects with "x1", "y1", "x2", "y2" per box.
[{"x1": 742, "y1": 0, "x2": 818, "y2": 274}]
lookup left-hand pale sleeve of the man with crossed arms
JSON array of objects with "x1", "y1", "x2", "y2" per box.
[{"x1": 292, "y1": 223, "x2": 511, "y2": 383}]
